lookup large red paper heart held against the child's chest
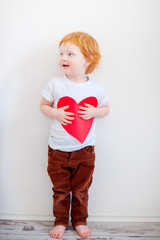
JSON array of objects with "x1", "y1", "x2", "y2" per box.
[{"x1": 57, "y1": 97, "x2": 98, "y2": 143}]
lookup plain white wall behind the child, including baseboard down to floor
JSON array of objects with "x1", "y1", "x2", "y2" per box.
[{"x1": 0, "y1": 0, "x2": 160, "y2": 221}]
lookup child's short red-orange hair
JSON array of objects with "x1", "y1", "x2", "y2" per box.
[{"x1": 59, "y1": 32, "x2": 101, "y2": 74}]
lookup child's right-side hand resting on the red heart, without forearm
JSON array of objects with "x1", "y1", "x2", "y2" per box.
[{"x1": 78, "y1": 103, "x2": 96, "y2": 120}]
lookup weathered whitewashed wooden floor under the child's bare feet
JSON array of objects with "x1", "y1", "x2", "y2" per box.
[{"x1": 0, "y1": 220, "x2": 160, "y2": 240}]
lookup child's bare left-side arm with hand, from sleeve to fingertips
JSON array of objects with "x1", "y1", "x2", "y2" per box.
[{"x1": 40, "y1": 98, "x2": 74, "y2": 125}]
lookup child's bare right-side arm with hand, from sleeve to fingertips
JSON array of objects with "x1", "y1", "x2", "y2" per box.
[{"x1": 78, "y1": 103, "x2": 110, "y2": 120}]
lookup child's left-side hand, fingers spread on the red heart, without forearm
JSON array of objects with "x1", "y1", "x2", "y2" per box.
[{"x1": 55, "y1": 106, "x2": 74, "y2": 125}]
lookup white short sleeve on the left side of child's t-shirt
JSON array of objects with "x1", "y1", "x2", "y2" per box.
[{"x1": 42, "y1": 79, "x2": 55, "y2": 102}]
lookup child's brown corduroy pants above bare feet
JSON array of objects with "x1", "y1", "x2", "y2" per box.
[{"x1": 47, "y1": 146, "x2": 95, "y2": 227}]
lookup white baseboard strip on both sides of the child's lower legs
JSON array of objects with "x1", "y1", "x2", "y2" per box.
[{"x1": 0, "y1": 212, "x2": 160, "y2": 222}]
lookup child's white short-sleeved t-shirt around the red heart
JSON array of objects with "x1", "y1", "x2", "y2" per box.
[{"x1": 42, "y1": 76, "x2": 108, "y2": 152}]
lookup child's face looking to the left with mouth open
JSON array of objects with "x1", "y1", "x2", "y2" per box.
[{"x1": 59, "y1": 43, "x2": 90, "y2": 77}]
